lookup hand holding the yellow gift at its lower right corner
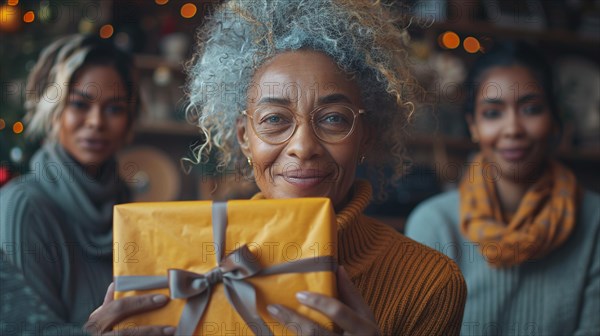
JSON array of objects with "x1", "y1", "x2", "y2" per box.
[{"x1": 267, "y1": 267, "x2": 379, "y2": 335}]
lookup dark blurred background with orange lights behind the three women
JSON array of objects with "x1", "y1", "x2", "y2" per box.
[{"x1": 0, "y1": 0, "x2": 600, "y2": 228}]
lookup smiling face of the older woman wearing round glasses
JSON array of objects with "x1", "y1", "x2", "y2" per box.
[{"x1": 237, "y1": 50, "x2": 368, "y2": 209}]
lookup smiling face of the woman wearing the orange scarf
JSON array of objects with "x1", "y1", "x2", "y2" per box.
[{"x1": 468, "y1": 65, "x2": 557, "y2": 182}]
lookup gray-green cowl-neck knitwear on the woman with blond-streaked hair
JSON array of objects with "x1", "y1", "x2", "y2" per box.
[{"x1": 0, "y1": 145, "x2": 128, "y2": 326}]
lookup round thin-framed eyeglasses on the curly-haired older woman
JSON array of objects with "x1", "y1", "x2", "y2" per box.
[{"x1": 242, "y1": 104, "x2": 365, "y2": 145}]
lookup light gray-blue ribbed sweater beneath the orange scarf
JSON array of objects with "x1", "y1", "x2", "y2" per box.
[{"x1": 406, "y1": 191, "x2": 600, "y2": 336}]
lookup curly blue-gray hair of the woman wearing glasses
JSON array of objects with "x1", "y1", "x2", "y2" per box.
[{"x1": 186, "y1": 0, "x2": 414, "y2": 192}]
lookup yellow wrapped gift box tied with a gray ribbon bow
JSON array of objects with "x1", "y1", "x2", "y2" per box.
[{"x1": 114, "y1": 198, "x2": 337, "y2": 335}]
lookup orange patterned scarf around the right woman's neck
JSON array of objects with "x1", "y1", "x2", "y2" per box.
[{"x1": 459, "y1": 155, "x2": 579, "y2": 268}]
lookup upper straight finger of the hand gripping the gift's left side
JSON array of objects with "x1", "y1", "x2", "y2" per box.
[{"x1": 84, "y1": 294, "x2": 169, "y2": 334}]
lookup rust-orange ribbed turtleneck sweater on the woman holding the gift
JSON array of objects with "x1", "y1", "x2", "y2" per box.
[{"x1": 253, "y1": 181, "x2": 467, "y2": 335}]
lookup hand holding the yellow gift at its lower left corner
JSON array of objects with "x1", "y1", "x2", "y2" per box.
[{"x1": 83, "y1": 283, "x2": 175, "y2": 336}]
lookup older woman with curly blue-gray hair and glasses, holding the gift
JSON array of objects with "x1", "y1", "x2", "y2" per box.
[{"x1": 90, "y1": 0, "x2": 466, "y2": 335}]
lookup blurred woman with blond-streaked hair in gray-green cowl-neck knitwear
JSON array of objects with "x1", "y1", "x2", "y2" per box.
[{"x1": 0, "y1": 35, "x2": 138, "y2": 325}]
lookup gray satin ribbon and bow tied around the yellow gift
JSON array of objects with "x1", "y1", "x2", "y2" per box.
[{"x1": 115, "y1": 202, "x2": 337, "y2": 336}]
